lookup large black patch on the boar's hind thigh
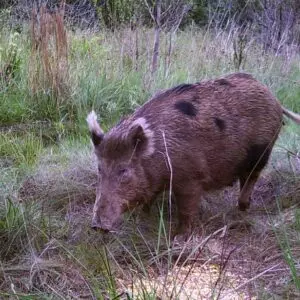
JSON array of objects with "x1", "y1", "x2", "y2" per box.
[{"x1": 237, "y1": 144, "x2": 271, "y2": 177}]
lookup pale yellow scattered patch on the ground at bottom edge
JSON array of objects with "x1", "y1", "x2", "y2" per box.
[{"x1": 119, "y1": 264, "x2": 252, "y2": 300}]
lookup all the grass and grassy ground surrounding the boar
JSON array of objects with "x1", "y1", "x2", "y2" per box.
[{"x1": 0, "y1": 14, "x2": 300, "y2": 299}]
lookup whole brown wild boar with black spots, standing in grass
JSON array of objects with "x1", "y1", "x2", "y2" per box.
[{"x1": 87, "y1": 73, "x2": 300, "y2": 236}]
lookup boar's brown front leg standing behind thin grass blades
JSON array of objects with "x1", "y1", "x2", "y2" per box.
[{"x1": 175, "y1": 185, "x2": 201, "y2": 241}]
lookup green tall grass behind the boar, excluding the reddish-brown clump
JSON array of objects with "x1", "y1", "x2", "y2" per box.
[{"x1": 0, "y1": 28, "x2": 299, "y2": 125}]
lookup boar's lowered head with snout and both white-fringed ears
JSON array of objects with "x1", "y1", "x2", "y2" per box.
[{"x1": 87, "y1": 111, "x2": 154, "y2": 232}]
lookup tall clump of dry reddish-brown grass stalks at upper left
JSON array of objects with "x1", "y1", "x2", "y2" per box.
[{"x1": 29, "y1": 2, "x2": 70, "y2": 103}]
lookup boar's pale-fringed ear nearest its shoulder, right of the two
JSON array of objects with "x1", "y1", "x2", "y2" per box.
[{"x1": 128, "y1": 118, "x2": 154, "y2": 156}]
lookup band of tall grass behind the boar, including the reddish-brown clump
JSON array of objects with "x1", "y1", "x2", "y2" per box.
[{"x1": 0, "y1": 22, "x2": 299, "y2": 124}]
